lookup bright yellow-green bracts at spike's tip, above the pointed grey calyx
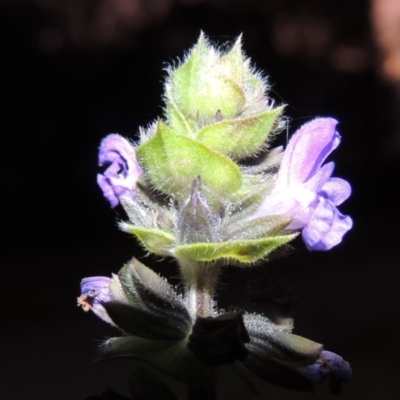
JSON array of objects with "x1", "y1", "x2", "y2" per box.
[{"x1": 137, "y1": 30, "x2": 283, "y2": 206}]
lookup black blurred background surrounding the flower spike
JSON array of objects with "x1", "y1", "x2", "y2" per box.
[{"x1": 0, "y1": 0, "x2": 400, "y2": 400}]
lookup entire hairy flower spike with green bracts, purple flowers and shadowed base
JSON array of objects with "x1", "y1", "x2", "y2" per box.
[{"x1": 82, "y1": 33, "x2": 353, "y2": 400}]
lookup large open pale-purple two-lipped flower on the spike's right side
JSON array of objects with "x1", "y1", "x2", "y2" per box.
[{"x1": 257, "y1": 118, "x2": 353, "y2": 250}]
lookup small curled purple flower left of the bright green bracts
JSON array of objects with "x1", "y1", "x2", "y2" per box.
[{"x1": 97, "y1": 134, "x2": 142, "y2": 207}]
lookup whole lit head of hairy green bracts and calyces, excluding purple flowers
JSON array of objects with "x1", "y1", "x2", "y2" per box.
[{"x1": 133, "y1": 34, "x2": 295, "y2": 265}]
